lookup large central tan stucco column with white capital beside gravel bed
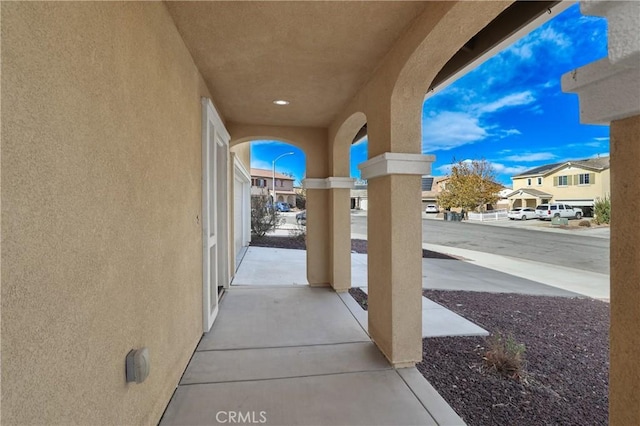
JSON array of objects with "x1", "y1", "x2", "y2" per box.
[{"x1": 359, "y1": 152, "x2": 433, "y2": 368}]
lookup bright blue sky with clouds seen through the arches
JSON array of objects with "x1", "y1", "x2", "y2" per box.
[{"x1": 251, "y1": 4, "x2": 609, "y2": 184}]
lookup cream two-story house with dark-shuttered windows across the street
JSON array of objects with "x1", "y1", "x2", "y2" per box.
[{"x1": 507, "y1": 157, "x2": 611, "y2": 216}]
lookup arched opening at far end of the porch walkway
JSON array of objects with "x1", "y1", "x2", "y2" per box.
[{"x1": 231, "y1": 139, "x2": 308, "y2": 286}]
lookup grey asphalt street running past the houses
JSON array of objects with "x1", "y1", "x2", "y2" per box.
[{"x1": 351, "y1": 215, "x2": 609, "y2": 274}]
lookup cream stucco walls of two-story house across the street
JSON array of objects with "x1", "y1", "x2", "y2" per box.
[{"x1": 513, "y1": 166, "x2": 611, "y2": 201}]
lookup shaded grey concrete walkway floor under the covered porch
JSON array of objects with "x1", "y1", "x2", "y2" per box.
[{"x1": 161, "y1": 286, "x2": 464, "y2": 425}]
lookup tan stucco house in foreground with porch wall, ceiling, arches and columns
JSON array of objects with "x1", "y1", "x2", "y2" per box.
[{"x1": 0, "y1": 1, "x2": 640, "y2": 425}]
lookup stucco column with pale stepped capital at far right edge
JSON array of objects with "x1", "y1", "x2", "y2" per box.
[{"x1": 562, "y1": 1, "x2": 640, "y2": 425}]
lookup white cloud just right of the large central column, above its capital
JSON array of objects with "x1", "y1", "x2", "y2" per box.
[{"x1": 422, "y1": 111, "x2": 489, "y2": 152}]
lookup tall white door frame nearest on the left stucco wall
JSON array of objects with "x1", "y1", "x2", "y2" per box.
[{"x1": 202, "y1": 98, "x2": 230, "y2": 333}]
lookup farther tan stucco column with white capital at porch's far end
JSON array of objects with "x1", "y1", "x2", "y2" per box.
[{"x1": 303, "y1": 177, "x2": 354, "y2": 292}]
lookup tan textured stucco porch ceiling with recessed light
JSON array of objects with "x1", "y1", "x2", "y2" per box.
[{"x1": 166, "y1": 1, "x2": 429, "y2": 127}]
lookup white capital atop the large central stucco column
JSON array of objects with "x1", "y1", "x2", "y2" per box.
[{"x1": 358, "y1": 152, "x2": 436, "y2": 179}]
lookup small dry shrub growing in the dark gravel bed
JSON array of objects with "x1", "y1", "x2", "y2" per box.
[{"x1": 483, "y1": 333, "x2": 526, "y2": 380}]
